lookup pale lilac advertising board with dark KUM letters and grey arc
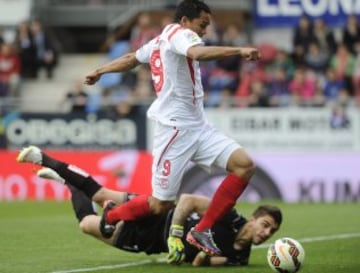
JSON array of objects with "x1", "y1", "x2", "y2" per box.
[{"x1": 190, "y1": 152, "x2": 360, "y2": 203}]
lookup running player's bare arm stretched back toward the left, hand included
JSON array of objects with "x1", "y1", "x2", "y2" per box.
[{"x1": 84, "y1": 52, "x2": 140, "y2": 85}]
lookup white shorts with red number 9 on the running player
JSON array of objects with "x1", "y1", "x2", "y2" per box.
[{"x1": 152, "y1": 123, "x2": 241, "y2": 201}]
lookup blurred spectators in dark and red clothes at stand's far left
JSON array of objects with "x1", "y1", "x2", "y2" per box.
[{"x1": 0, "y1": 20, "x2": 58, "y2": 98}]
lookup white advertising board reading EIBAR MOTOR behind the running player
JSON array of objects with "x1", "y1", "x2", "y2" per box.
[{"x1": 206, "y1": 108, "x2": 360, "y2": 152}]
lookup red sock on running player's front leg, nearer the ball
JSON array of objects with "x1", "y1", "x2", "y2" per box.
[{"x1": 195, "y1": 174, "x2": 249, "y2": 231}]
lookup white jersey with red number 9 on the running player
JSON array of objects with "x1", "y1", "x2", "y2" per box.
[{"x1": 136, "y1": 24, "x2": 207, "y2": 128}]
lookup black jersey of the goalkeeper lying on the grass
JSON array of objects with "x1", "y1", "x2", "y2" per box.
[{"x1": 115, "y1": 207, "x2": 251, "y2": 265}]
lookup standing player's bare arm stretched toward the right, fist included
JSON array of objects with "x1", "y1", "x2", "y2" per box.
[{"x1": 187, "y1": 45, "x2": 261, "y2": 61}]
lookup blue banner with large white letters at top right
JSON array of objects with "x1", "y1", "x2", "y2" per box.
[{"x1": 253, "y1": 0, "x2": 360, "y2": 27}]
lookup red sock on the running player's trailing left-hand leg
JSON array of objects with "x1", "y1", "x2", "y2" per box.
[{"x1": 106, "y1": 195, "x2": 151, "y2": 223}]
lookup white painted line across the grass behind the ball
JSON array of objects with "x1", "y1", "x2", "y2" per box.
[{"x1": 50, "y1": 233, "x2": 360, "y2": 273}]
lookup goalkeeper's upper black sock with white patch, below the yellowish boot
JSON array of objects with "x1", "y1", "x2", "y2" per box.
[{"x1": 42, "y1": 153, "x2": 101, "y2": 199}]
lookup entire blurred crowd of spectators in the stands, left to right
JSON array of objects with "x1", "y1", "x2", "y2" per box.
[{"x1": 0, "y1": 13, "x2": 360, "y2": 115}]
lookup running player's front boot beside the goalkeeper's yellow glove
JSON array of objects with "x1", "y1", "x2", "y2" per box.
[{"x1": 186, "y1": 225, "x2": 221, "y2": 256}]
